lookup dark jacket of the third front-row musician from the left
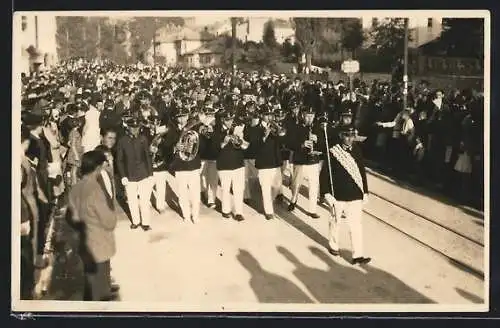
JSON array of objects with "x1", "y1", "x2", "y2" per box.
[{"x1": 213, "y1": 125, "x2": 245, "y2": 171}]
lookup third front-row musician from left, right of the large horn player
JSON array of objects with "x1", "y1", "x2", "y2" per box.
[{"x1": 213, "y1": 110, "x2": 249, "y2": 221}]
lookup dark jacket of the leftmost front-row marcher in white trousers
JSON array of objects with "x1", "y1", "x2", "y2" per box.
[{"x1": 116, "y1": 134, "x2": 153, "y2": 182}]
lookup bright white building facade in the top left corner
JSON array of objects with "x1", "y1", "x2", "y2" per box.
[{"x1": 14, "y1": 13, "x2": 58, "y2": 74}]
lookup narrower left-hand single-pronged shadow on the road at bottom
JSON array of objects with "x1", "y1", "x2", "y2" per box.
[{"x1": 236, "y1": 249, "x2": 313, "y2": 303}]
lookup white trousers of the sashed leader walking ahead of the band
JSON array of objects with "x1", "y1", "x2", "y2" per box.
[{"x1": 328, "y1": 200, "x2": 364, "y2": 258}]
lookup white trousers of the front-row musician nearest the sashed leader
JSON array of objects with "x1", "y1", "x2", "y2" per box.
[{"x1": 291, "y1": 164, "x2": 319, "y2": 213}]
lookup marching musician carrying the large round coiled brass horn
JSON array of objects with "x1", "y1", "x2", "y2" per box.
[{"x1": 165, "y1": 107, "x2": 201, "y2": 223}]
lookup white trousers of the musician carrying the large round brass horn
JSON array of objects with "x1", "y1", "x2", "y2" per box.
[{"x1": 175, "y1": 169, "x2": 201, "y2": 221}]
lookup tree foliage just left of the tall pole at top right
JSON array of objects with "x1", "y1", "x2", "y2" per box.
[{"x1": 370, "y1": 18, "x2": 411, "y2": 60}]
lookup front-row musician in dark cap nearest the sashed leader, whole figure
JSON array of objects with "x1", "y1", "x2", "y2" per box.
[{"x1": 288, "y1": 107, "x2": 321, "y2": 219}]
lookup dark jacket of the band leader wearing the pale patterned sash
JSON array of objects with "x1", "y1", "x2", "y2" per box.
[{"x1": 319, "y1": 143, "x2": 368, "y2": 201}]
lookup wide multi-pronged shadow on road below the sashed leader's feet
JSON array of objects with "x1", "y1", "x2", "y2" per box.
[{"x1": 277, "y1": 246, "x2": 435, "y2": 304}]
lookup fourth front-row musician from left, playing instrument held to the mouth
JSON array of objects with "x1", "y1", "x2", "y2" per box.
[{"x1": 255, "y1": 107, "x2": 286, "y2": 220}]
